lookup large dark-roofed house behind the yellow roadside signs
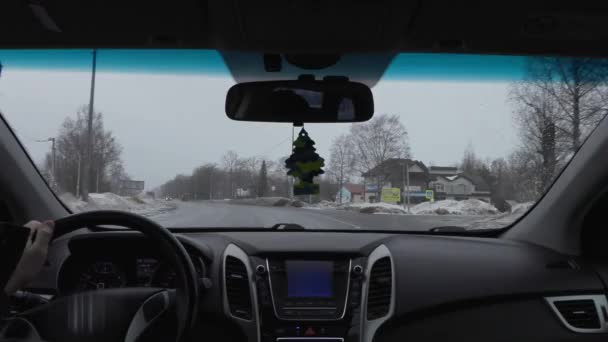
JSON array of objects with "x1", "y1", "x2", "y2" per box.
[{"x1": 362, "y1": 158, "x2": 431, "y2": 203}]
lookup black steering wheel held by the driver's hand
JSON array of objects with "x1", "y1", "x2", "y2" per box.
[{"x1": 22, "y1": 210, "x2": 199, "y2": 342}]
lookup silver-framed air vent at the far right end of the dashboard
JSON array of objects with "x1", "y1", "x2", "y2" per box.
[{"x1": 553, "y1": 299, "x2": 601, "y2": 329}]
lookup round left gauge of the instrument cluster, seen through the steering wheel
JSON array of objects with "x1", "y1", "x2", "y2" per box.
[{"x1": 78, "y1": 261, "x2": 126, "y2": 291}]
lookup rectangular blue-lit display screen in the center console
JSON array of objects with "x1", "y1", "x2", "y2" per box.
[{"x1": 285, "y1": 260, "x2": 334, "y2": 298}]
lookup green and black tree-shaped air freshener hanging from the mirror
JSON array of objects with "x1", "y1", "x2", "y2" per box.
[{"x1": 285, "y1": 128, "x2": 325, "y2": 196}]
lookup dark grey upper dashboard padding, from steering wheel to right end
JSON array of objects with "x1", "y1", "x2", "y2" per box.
[{"x1": 47, "y1": 231, "x2": 604, "y2": 314}]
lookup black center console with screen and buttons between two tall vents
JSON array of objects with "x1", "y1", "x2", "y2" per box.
[{"x1": 252, "y1": 256, "x2": 363, "y2": 342}]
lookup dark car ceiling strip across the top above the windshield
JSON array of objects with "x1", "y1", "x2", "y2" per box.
[{"x1": 0, "y1": 0, "x2": 608, "y2": 56}]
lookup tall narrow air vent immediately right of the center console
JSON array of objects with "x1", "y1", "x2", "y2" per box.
[{"x1": 367, "y1": 257, "x2": 393, "y2": 320}]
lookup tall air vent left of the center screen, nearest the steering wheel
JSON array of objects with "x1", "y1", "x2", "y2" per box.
[{"x1": 225, "y1": 256, "x2": 252, "y2": 320}]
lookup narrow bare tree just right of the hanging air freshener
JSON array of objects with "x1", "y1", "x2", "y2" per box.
[{"x1": 327, "y1": 134, "x2": 355, "y2": 203}]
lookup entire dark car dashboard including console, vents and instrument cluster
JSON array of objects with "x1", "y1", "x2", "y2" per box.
[{"x1": 38, "y1": 231, "x2": 608, "y2": 342}]
